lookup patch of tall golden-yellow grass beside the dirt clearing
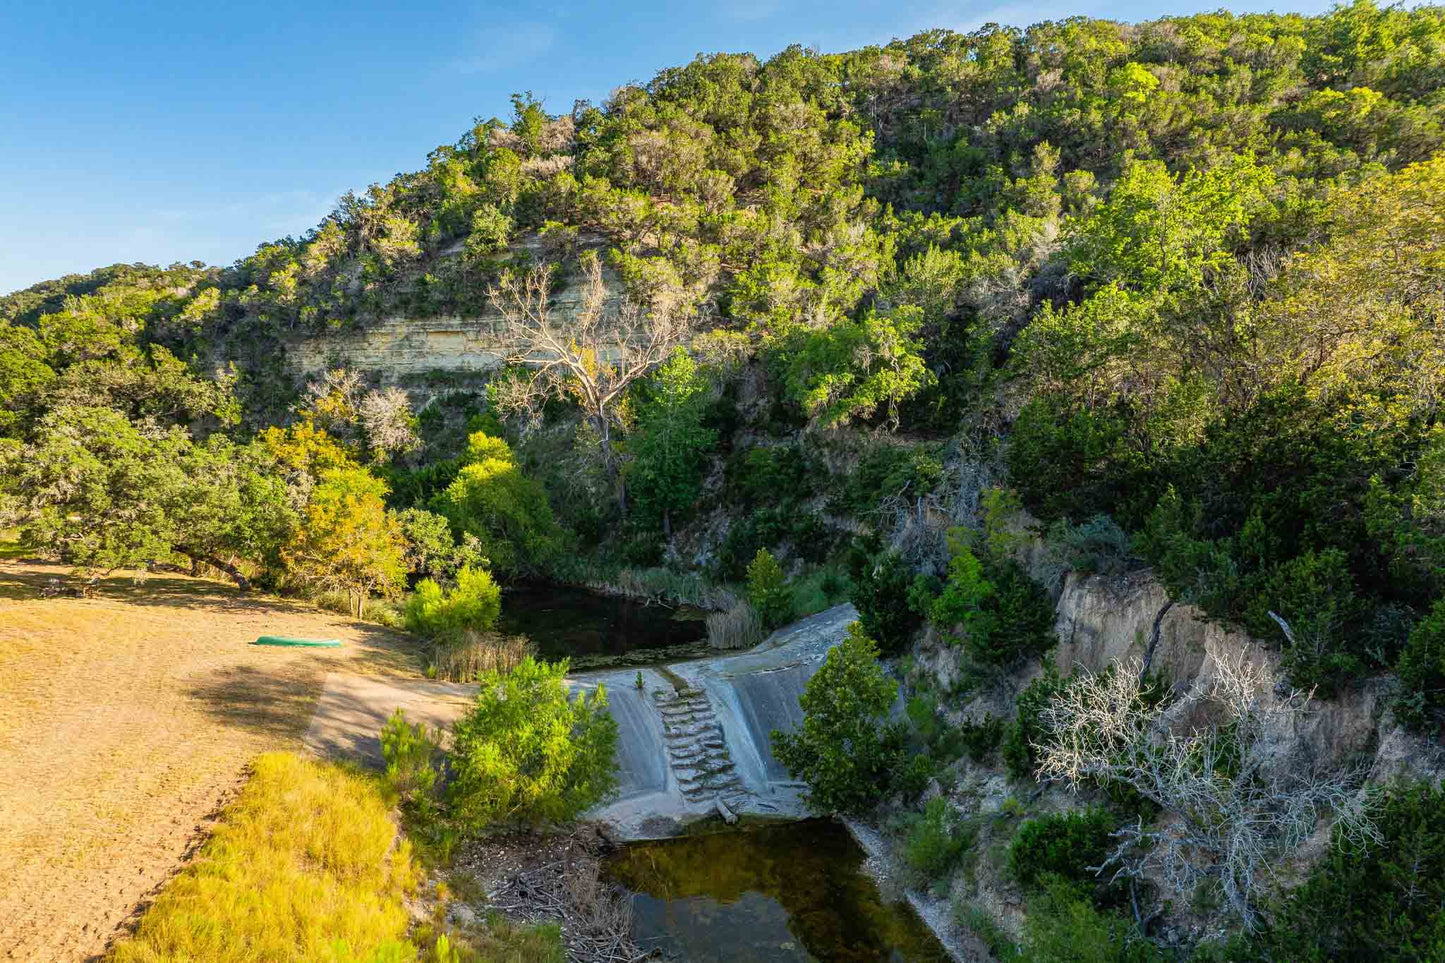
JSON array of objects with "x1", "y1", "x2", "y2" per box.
[{"x1": 110, "y1": 752, "x2": 416, "y2": 963}]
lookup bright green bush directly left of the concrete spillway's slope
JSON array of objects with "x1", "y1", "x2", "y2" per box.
[{"x1": 447, "y1": 656, "x2": 617, "y2": 830}]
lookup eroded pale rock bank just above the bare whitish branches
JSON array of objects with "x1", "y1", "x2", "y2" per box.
[{"x1": 1053, "y1": 574, "x2": 1445, "y2": 781}]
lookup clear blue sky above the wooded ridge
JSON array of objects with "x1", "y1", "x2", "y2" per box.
[{"x1": 0, "y1": 0, "x2": 1328, "y2": 294}]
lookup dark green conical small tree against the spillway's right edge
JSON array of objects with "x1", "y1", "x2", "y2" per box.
[{"x1": 772, "y1": 622, "x2": 902, "y2": 813}]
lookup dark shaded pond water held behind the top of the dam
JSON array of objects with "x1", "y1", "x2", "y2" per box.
[{"x1": 497, "y1": 586, "x2": 708, "y2": 668}]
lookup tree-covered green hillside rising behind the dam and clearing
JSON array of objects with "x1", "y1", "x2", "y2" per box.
[{"x1": 0, "y1": 0, "x2": 1445, "y2": 942}]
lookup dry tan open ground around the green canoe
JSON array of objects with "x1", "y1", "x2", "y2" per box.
[{"x1": 0, "y1": 561, "x2": 420, "y2": 963}]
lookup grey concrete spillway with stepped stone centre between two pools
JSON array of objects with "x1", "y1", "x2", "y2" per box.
[{"x1": 572, "y1": 606, "x2": 858, "y2": 839}]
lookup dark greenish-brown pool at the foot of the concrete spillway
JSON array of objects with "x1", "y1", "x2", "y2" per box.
[{"x1": 608, "y1": 820, "x2": 948, "y2": 963}]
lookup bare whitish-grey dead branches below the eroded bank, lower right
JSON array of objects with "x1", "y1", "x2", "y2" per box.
[{"x1": 1038, "y1": 646, "x2": 1379, "y2": 928}]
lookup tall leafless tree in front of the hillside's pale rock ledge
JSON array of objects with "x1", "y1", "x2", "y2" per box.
[{"x1": 487, "y1": 252, "x2": 692, "y2": 512}]
